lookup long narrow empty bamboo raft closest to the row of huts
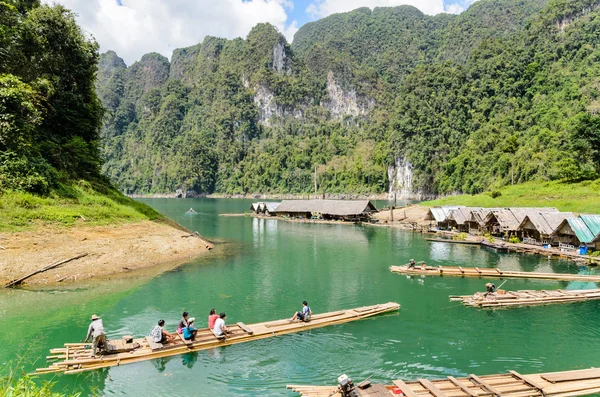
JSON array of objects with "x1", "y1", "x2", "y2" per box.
[{"x1": 390, "y1": 265, "x2": 600, "y2": 282}]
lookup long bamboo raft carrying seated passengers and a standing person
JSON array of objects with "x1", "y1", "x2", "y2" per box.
[{"x1": 35, "y1": 302, "x2": 400, "y2": 374}]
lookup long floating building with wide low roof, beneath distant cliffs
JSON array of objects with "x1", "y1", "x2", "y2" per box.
[{"x1": 275, "y1": 200, "x2": 377, "y2": 222}]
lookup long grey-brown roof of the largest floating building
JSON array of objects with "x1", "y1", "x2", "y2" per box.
[{"x1": 276, "y1": 200, "x2": 377, "y2": 216}]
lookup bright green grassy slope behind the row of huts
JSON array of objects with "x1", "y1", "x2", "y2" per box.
[{"x1": 422, "y1": 179, "x2": 600, "y2": 214}]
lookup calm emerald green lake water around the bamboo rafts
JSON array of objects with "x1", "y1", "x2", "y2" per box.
[{"x1": 0, "y1": 199, "x2": 600, "y2": 397}]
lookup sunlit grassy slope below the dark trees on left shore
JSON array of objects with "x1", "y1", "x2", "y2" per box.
[{"x1": 0, "y1": 181, "x2": 167, "y2": 232}]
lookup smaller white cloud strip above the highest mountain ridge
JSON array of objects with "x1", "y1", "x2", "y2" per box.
[{"x1": 306, "y1": 0, "x2": 445, "y2": 18}]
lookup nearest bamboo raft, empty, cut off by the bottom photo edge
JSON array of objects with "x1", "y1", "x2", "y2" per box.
[{"x1": 287, "y1": 368, "x2": 600, "y2": 397}]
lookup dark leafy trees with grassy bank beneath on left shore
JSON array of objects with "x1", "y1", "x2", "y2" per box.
[{"x1": 0, "y1": 0, "x2": 160, "y2": 231}]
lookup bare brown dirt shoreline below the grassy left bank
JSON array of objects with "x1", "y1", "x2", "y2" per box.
[{"x1": 0, "y1": 221, "x2": 213, "y2": 285}]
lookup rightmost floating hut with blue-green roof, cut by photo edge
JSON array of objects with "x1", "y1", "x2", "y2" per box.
[{"x1": 552, "y1": 215, "x2": 600, "y2": 250}]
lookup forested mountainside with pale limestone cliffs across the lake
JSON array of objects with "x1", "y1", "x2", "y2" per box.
[{"x1": 97, "y1": 0, "x2": 600, "y2": 195}]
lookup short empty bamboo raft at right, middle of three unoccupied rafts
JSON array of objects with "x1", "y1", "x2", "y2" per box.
[{"x1": 450, "y1": 289, "x2": 600, "y2": 308}]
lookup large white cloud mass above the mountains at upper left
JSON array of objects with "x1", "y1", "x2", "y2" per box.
[{"x1": 44, "y1": 0, "x2": 298, "y2": 64}]
